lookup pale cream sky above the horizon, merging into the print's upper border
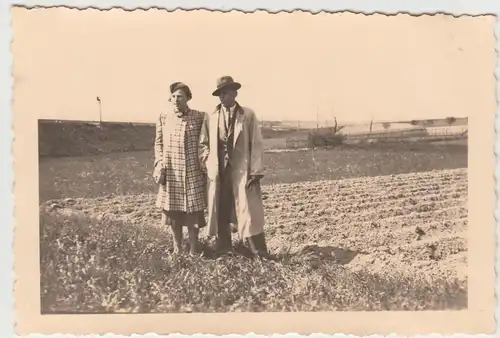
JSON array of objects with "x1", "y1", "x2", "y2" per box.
[{"x1": 12, "y1": 8, "x2": 496, "y2": 122}]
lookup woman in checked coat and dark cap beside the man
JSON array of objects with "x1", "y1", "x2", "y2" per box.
[{"x1": 153, "y1": 82, "x2": 206, "y2": 254}]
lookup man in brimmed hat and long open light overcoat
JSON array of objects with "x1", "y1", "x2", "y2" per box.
[{"x1": 200, "y1": 76, "x2": 269, "y2": 257}]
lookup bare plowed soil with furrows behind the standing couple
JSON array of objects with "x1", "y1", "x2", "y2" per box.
[{"x1": 41, "y1": 169, "x2": 467, "y2": 281}]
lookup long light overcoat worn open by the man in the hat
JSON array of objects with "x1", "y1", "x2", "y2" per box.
[{"x1": 200, "y1": 104, "x2": 264, "y2": 238}]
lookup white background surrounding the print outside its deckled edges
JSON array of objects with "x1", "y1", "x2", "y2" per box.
[{"x1": 0, "y1": 0, "x2": 500, "y2": 338}]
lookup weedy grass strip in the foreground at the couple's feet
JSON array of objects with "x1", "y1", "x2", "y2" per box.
[{"x1": 40, "y1": 211, "x2": 467, "y2": 314}]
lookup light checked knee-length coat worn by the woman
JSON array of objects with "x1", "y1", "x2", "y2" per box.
[{"x1": 154, "y1": 110, "x2": 206, "y2": 213}]
